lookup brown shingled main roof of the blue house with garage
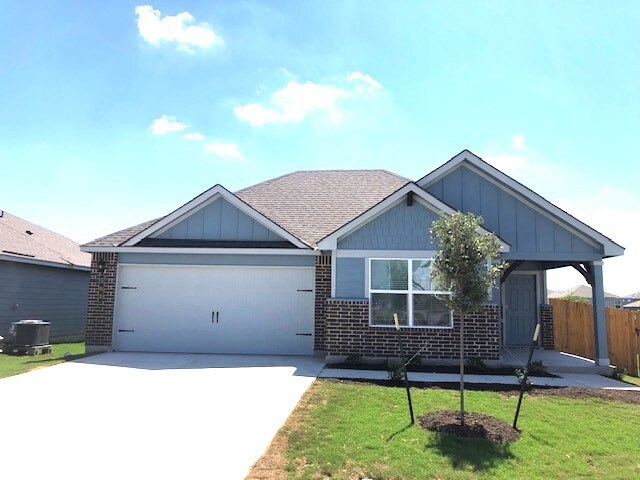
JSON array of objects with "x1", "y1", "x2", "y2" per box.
[{"x1": 86, "y1": 170, "x2": 410, "y2": 247}]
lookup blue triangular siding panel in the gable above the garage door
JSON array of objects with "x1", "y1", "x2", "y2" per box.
[{"x1": 152, "y1": 198, "x2": 284, "y2": 241}]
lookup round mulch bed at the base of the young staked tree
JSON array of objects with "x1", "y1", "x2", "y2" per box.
[{"x1": 418, "y1": 410, "x2": 520, "y2": 443}]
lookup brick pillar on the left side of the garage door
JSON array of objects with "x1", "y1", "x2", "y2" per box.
[{"x1": 85, "y1": 253, "x2": 118, "y2": 352}]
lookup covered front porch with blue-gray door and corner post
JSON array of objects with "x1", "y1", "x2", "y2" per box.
[{"x1": 500, "y1": 257, "x2": 610, "y2": 372}]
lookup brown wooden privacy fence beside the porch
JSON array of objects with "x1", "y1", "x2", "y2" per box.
[{"x1": 550, "y1": 298, "x2": 640, "y2": 376}]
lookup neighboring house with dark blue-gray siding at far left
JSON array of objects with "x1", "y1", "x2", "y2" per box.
[{"x1": 0, "y1": 210, "x2": 91, "y2": 341}]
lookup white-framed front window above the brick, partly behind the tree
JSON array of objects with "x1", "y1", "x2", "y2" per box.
[{"x1": 369, "y1": 258, "x2": 453, "y2": 328}]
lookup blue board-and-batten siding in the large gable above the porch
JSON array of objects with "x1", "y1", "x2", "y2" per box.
[{"x1": 427, "y1": 166, "x2": 602, "y2": 261}]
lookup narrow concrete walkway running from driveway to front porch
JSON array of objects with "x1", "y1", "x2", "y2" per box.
[{"x1": 319, "y1": 368, "x2": 640, "y2": 392}]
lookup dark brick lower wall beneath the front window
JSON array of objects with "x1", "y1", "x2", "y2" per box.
[{"x1": 325, "y1": 298, "x2": 500, "y2": 360}]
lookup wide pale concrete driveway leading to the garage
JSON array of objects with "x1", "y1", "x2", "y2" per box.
[{"x1": 0, "y1": 353, "x2": 322, "y2": 480}]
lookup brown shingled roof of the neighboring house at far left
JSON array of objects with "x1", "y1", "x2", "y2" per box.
[{"x1": 0, "y1": 210, "x2": 91, "y2": 268}]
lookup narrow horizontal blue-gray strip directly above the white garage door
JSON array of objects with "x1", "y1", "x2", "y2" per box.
[{"x1": 118, "y1": 253, "x2": 316, "y2": 267}]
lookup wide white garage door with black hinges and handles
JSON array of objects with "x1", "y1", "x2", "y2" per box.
[{"x1": 114, "y1": 265, "x2": 314, "y2": 355}]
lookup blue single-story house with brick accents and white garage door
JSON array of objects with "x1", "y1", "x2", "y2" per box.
[{"x1": 82, "y1": 150, "x2": 624, "y2": 365}]
